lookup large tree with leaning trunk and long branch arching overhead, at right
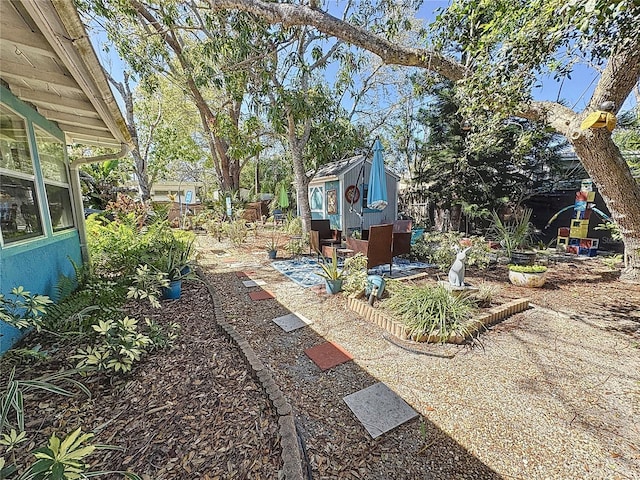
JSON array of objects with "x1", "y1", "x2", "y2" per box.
[{"x1": 208, "y1": 0, "x2": 640, "y2": 278}]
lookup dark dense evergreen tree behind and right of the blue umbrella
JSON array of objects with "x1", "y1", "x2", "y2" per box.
[{"x1": 412, "y1": 81, "x2": 563, "y2": 230}]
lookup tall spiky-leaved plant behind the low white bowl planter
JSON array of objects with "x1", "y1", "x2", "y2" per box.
[{"x1": 490, "y1": 208, "x2": 536, "y2": 265}]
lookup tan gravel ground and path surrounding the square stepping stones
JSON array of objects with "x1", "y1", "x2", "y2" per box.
[{"x1": 198, "y1": 230, "x2": 640, "y2": 479}]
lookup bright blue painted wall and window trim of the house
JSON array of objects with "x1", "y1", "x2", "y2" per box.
[{"x1": 0, "y1": 86, "x2": 82, "y2": 354}]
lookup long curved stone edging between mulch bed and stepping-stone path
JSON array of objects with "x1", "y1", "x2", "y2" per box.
[{"x1": 197, "y1": 269, "x2": 304, "y2": 480}]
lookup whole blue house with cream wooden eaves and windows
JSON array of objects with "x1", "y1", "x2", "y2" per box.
[{"x1": 0, "y1": 0, "x2": 130, "y2": 353}]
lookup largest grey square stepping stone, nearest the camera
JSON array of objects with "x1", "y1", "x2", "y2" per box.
[{"x1": 344, "y1": 382, "x2": 418, "y2": 438}]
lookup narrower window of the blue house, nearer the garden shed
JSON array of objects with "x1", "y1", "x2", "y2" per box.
[{"x1": 35, "y1": 128, "x2": 74, "y2": 232}]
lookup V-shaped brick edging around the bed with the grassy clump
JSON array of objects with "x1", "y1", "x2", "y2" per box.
[{"x1": 347, "y1": 296, "x2": 529, "y2": 344}]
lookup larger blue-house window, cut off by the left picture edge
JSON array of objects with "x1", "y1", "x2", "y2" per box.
[{"x1": 0, "y1": 105, "x2": 43, "y2": 244}]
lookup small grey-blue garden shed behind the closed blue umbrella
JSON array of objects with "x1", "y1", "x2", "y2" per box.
[{"x1": 309, "y1": 155, "x2": 400, "y2": 236}]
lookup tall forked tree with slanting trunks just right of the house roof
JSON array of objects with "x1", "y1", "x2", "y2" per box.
[{"x1": 83, "y1": 0, "x2": 262, "y2": 190}]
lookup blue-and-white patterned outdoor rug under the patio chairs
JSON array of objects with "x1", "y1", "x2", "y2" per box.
[{"x1": 271, "y1": 257, "x2": 434, "y2": 288}]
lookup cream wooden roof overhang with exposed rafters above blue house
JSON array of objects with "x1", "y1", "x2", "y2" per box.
[{"x1": 0, "y1": 0, "x2": 131, "y2": 149}]
